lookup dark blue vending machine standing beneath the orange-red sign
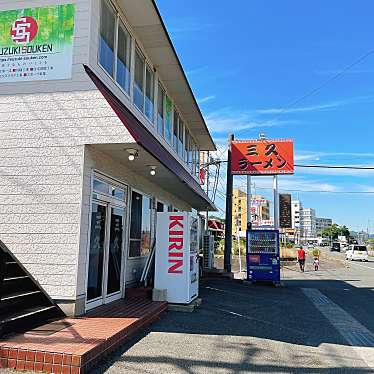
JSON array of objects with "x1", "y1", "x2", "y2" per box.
[{"x1": 247, "y1": 229, "x2": 280, "y2": 285}]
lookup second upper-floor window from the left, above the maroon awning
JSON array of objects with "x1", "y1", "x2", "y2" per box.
[{"x1": 117, "y1": 22, "x2": 131, "y2": 93}]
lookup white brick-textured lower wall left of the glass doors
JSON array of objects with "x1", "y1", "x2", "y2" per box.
[{"x1": 0, "y1": 85, "x2": 142, "y2": 299}]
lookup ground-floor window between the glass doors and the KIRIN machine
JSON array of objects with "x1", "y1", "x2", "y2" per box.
[{"x1": 129, "y1": 191, "x2": 151, "y2": 257}]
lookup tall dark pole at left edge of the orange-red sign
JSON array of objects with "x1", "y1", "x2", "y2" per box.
[{"x1": 224, "y1": 134, "x2": 234, "y2": 273}]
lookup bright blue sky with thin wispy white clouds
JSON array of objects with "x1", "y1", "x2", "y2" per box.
[{"x1": 157, "y1": 0, "x2": 374, "y2": 232}]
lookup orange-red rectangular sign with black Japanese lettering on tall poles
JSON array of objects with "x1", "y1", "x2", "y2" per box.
[{"x1": 231, "y1": 139, "x2": 294, "y2": 175}]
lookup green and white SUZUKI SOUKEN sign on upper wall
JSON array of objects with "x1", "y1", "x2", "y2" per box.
[{"x1": 0, "y1": 4, "x2": 75, "y2": 84}]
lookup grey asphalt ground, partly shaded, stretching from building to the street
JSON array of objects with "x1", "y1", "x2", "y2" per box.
[{"x1": 93, "y1": 251, "x2": 374, "y2": 374}]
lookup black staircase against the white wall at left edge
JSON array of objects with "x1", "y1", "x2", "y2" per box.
[{"x1": 0, "y1": 241, "x2": 63, "y2": 336}]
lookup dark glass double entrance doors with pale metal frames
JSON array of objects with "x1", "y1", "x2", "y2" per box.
[{"x1": 87, "y1": 200, "x2": 125, "y2": 309}]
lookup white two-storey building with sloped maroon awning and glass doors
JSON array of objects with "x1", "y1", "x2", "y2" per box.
[{"x1": 0, "y1": 0, "x2": 215, "y2": 315}]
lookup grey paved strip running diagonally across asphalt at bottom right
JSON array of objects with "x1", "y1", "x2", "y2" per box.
[{"x1": 302, "y1": 288, "x2": 374, "y2": 368}]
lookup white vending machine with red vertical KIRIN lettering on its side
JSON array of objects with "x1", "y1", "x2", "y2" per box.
[{"x1": 154, "y1": 212, "x2": 199, "y2": 304}]
